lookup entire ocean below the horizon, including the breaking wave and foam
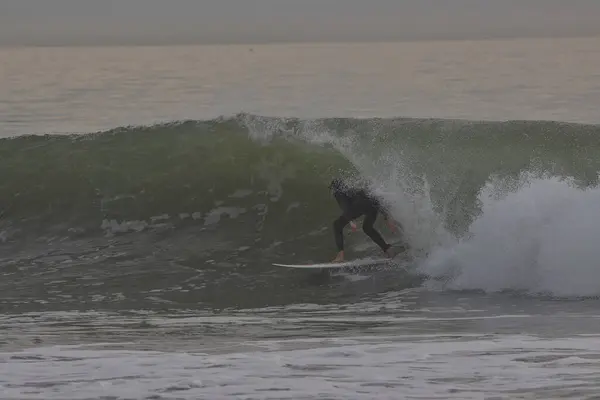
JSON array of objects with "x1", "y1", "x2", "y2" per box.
[{"x1": 0, "y1": 38, "x2": 600, "y2": 400}]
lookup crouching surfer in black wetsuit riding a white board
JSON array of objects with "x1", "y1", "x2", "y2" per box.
[{"x1": 329, "y1": 178, "x2": 404, "y2": 262}]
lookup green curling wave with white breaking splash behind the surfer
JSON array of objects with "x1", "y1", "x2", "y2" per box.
[{"x1": 0, "y1": 114, "x2": 600, "y2": 295}]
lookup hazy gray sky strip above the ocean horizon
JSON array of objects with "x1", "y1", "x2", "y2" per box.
[{"x1": 0, "y1": 0, "x2": 600, "y2": 45}]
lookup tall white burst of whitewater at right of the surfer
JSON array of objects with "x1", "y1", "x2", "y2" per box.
[{"x1": 421, "y1": 178, "x2": 600, "y2": 296}]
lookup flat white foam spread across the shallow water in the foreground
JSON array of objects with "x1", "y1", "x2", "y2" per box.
[{"x1": 0, "y1": 335, "x2": 600, "y2": 400}]
